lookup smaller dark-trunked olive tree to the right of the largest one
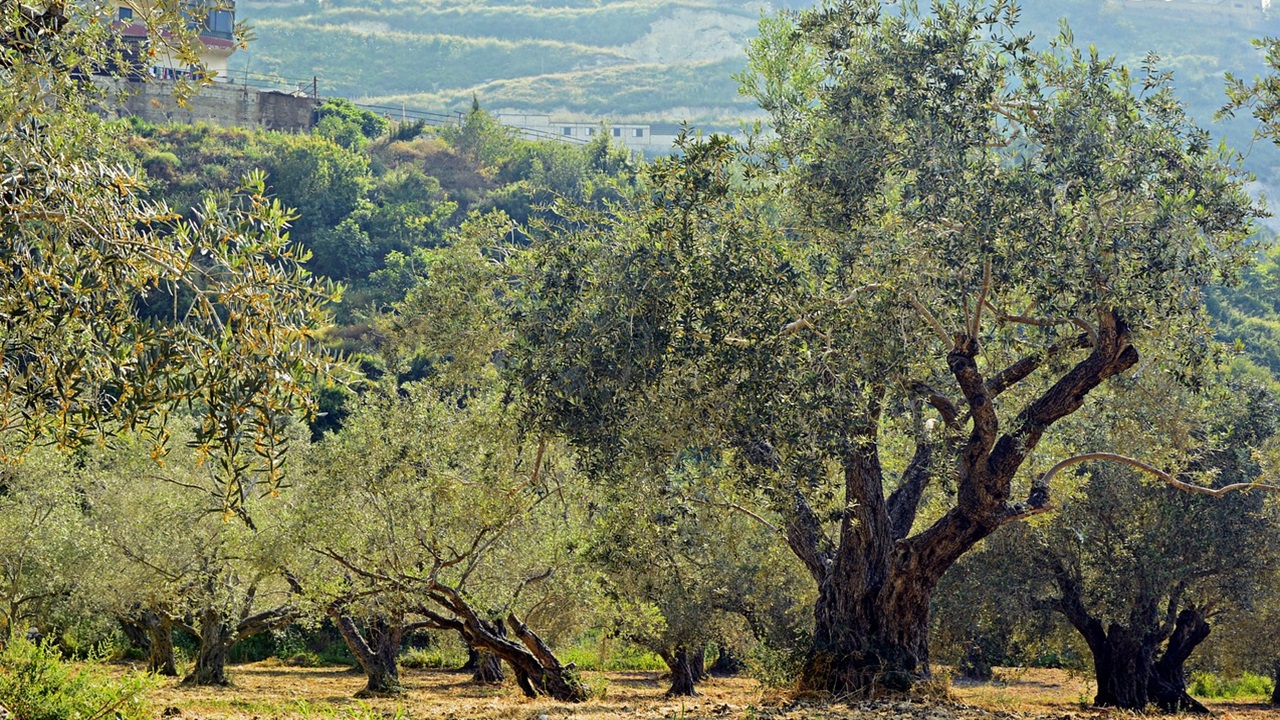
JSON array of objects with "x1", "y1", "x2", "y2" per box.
[{"x1": 947, "y1": 377, "x2": 1280, "y2": 712}]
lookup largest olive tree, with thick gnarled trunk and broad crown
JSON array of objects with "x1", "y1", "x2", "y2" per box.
[{"x1": 512, "y1": 0, "x2": 1256, "y2": 693}]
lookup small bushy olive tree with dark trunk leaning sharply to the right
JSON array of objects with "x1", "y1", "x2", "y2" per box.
[{"x1": 296, "y1": 380, "x2": 585, "y2": 701}]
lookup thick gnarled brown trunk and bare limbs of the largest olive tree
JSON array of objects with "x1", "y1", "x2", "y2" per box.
[{"x1": 788, "y1": 313, "x2": 1138, "y2": 694}]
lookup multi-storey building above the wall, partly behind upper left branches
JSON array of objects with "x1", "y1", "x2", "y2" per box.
[{"x1": 113, "y1": 0, "x2": 236, "y2": 82}]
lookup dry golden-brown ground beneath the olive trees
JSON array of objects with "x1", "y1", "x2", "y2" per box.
[{"x1": 145, "y1": 661, "x2": 1280, "y2": 720}]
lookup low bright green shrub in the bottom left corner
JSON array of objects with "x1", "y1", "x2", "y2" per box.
[{"x1": 0, "y1": 639, "x2": 154, "y2": 720}]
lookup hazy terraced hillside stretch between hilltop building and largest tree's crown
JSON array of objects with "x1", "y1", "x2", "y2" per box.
[{"x1": 236, "y1": 0, "x2": 764, "y2": 118}]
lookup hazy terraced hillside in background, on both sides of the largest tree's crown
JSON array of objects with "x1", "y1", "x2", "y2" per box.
[{"x1": 232, "y1": 0, "x2": 1280, "y2": 143}]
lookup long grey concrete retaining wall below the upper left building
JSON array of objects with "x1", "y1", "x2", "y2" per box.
[{"x1": 101, "y1": 78, "x2": 319, "y2": 132}]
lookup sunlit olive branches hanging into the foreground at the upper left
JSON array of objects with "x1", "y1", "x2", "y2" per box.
[{"x1": 0, "y1": 0, "x2": 333, "y2": 506}]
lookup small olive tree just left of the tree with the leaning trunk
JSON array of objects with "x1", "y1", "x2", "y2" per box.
[{"x1": 83, "y1": 432, "x2": 302, "y2": 685}]
